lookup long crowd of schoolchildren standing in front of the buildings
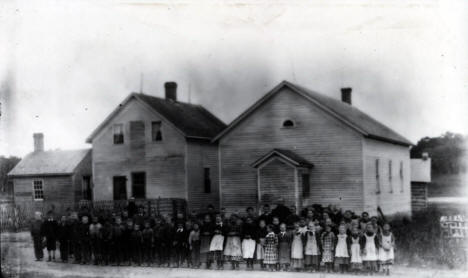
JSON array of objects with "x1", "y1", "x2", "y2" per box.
[{"x1": 31, "y1": 204, "x2": 395, "y2": 275}]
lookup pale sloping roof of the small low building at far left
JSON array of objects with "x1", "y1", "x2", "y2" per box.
[{"x1": 8, "y1": 149, "x2": 91, "y2": 176}]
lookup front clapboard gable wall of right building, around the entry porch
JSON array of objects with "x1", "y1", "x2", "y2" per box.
[{"x1": 219, "y1": 89, "x2": 363, "y2": 214}]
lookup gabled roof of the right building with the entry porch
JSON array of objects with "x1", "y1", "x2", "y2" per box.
[{"x1": 213, "y1": 81, "x2": 412, "y2": 146}]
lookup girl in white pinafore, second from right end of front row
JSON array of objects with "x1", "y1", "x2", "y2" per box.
[{"x1": 361, "y1": 222, "x2": 379, "y2": 274}]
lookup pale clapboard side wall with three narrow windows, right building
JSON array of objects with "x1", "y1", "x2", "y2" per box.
[{"x1": 363, "y1": 138, "x2": 411, "y2": 215}]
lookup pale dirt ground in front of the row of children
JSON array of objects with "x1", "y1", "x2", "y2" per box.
[{"x1": 1, "y1": 232, "x2": 466, "y2": 278}]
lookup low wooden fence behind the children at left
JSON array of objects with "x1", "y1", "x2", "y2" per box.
[{"x1": 0, "y1": 198, "x2": 187, "y2": 232}]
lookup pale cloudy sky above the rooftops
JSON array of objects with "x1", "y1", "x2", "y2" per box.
[{"x1": 0, "y1": 0, "x2": 468, "y2": 157}]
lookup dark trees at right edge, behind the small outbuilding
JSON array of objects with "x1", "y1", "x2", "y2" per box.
[{"x1": 411, "y1": 132, "x2": 468, "y2": 175}]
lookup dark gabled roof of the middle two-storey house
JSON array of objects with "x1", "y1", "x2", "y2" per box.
[{"x1": 86, "y1": 93, "x2": 226, "y2": 143}]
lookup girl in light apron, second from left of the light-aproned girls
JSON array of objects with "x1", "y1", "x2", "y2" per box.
[{"x1": 224, "y1": 216, "x2": 242, "y2": 270}]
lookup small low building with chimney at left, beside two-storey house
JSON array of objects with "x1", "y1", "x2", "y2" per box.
[{"x1": 8, "y1": 133, "x2": 92, "y2": 212}]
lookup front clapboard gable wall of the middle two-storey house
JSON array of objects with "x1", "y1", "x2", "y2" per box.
[{"x1": 93, "y1": 100, "x2": 186, "y2": 200}]
